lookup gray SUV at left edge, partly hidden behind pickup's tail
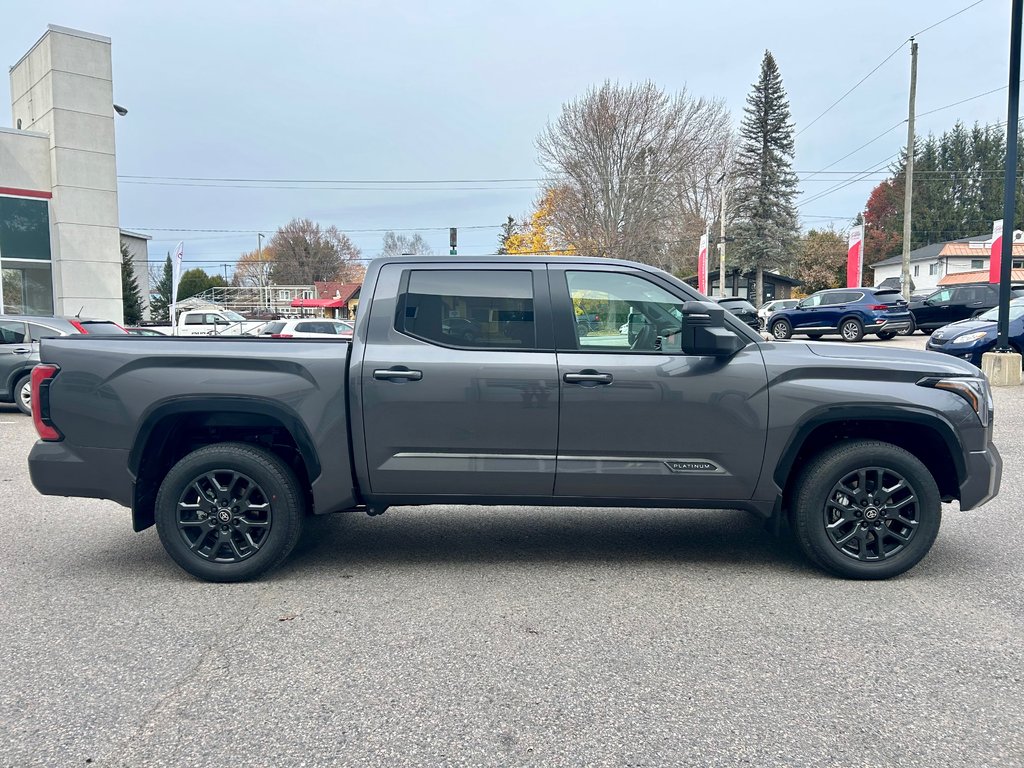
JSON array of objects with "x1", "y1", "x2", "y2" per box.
[{"x1": 0, "y1": 314, "x2": 124, "y2": 415}]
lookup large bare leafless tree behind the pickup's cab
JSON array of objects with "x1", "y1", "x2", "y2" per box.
[{"x1": 537, "y1": 82, "x2": 729, "y2": 268}]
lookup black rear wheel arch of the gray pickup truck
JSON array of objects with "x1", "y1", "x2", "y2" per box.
[{"x1": 128, "y1": 397, "x2": 322, "y2": 531}]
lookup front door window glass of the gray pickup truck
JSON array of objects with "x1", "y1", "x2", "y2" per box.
[{"x1": 565, "y1": 271, "x2": 683, "y2": 354}]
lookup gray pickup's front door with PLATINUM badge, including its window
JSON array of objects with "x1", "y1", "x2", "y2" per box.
[{"x1": 549, "y1": 265, "x2": 768, "y2": 500}]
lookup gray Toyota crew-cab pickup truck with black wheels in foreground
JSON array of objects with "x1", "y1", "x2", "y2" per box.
[{"x1": 29, "y1": 257, "x2": 1001, "y2": 582}]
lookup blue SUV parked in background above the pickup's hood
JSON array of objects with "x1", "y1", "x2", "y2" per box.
[{"x1": 768, "y1": 288, "x2": 913, "y2": 341}]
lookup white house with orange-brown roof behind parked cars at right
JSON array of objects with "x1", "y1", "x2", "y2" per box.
[{"x1": 871, "y1": 230, "x2": 1024, "y2": 291}]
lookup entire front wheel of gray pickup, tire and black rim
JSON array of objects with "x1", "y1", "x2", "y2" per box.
[{"x1": 790, "y1": 440, "x2": 942, "y2": 579}]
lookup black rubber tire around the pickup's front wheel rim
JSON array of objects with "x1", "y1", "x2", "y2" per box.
[{"x1": 792, "y1": 441, "x2": 942, "y2": 580}]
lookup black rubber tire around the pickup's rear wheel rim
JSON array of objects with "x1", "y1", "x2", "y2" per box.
[{"x1": 156, "y1": 443, "x2": 303, "y2": 582}]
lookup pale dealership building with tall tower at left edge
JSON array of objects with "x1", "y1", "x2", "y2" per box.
[{"x1": 0, "y1": 25, "x2": 130, "y2": 322}]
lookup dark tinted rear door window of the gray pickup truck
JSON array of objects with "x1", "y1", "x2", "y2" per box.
[{"x1": 395, "y1": 269, "x2": 537, "y2": 349}]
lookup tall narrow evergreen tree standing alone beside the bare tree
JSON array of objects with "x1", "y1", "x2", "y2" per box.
[{"x1": 732, "y1": 50, "x2": 800, "y2": 305}]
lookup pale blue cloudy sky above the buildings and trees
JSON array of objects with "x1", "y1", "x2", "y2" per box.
[{"x1": 0, "y1": 0, "x2": 1011, "y2": 273}]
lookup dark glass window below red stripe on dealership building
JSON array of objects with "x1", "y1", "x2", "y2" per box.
[{"x1": 0, "y1": 197, "x2": 53, "y2": 315}]
